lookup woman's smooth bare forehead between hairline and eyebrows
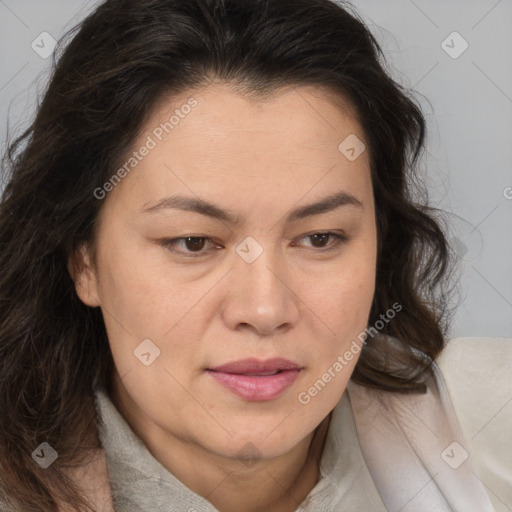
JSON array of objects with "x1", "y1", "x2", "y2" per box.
[{"x1": 102, "y1": 83, "x2": 369, "y2": 216}]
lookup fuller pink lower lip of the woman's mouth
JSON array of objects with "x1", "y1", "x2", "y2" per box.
[{"x1": 208, "y1": 370, "x2": 300, "y2": 401}]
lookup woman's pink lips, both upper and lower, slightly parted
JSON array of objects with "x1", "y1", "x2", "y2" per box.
[{"x1": 207, "y1": 358, "x2": 302, "y2": 401}]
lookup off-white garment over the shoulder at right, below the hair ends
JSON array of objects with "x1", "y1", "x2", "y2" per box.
[{"x1": 348, "y1": 338, "x2": 512, "y2": 512}]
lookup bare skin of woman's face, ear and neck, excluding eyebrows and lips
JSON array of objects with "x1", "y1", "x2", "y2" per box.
[{"x1": 70, "y1": 82, "x2": 377, "y2": 512}]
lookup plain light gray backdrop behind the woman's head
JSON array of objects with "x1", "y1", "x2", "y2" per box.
[{"x1": 0, "y1": 0, "x2": 512, "y2": 337}]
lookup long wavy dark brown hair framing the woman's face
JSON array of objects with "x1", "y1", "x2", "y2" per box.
[{"x1": 0, "y1": 0, "x2": 451, "y2": 512}]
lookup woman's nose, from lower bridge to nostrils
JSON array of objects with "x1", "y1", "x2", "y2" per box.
[{"x1": 222, "y1": 243, "x2": 300, "y2": 336}]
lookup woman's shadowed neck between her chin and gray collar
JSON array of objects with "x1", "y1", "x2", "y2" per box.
[{"x1": 111, "y1": 374, "x2": 331, "y2": 512}]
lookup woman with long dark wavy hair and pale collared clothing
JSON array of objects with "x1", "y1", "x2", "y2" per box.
[{"x1": 0, "y1": 0, "x2": 510, "y2": 512}]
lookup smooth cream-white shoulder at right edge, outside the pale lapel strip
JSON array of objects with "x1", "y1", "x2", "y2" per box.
[{"x1": 436, "y1": 337, "x2": 512, "y2": 510}]
